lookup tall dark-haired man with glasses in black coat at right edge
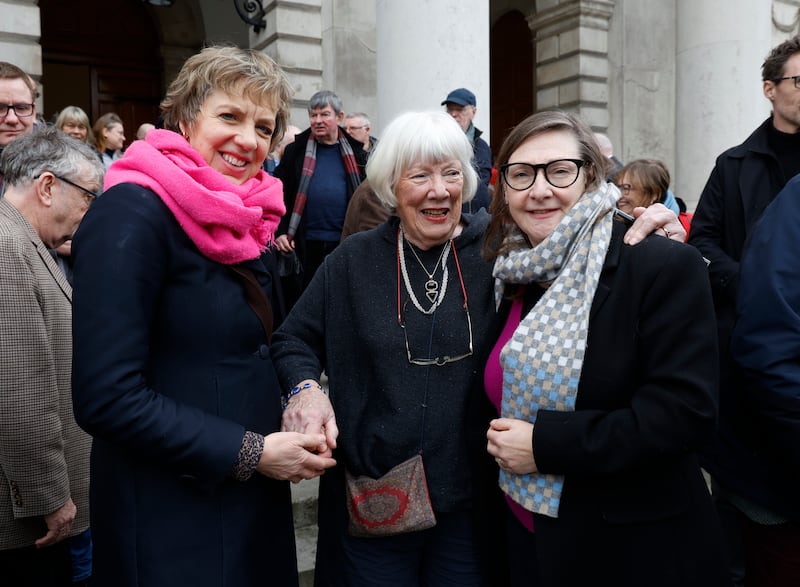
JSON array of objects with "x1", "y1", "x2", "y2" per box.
[{"x1": 689, "y1": 36, "x2": 800, "y2": 585}]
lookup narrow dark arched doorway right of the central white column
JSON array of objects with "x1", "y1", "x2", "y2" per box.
[{"x1": 490, "y1": 10, "x2": 536, "y2": 156}]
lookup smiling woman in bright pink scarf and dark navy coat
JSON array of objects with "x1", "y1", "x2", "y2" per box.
[{"x1": 67, "y1": 47, "x2": 334, "y2": 587}]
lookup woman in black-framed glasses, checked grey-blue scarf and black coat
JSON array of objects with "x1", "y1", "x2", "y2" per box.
[{"x1": 484, "y1": 111, "x2": 728, "y2": 587}]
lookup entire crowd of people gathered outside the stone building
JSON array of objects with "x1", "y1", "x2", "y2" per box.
[{"x1": 0, "y1": 31, "x2": 800, "y2": 587}]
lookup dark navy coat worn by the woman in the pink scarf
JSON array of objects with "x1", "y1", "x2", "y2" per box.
[{"x1": 73, "y1": 184, "x2": 297, "y2": 587}]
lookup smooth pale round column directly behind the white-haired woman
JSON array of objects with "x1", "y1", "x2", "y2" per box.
[{"x1": 373, "y1": 0, "x2": 490, "y2": 137}]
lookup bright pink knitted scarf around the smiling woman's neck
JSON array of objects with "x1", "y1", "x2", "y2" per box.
[{"x1": 105, "y1": 130, "x2": 286, "y2": 265}]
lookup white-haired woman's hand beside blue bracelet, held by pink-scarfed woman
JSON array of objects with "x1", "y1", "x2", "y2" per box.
[{"x1": 281, "y1": 382, "x2": 339, "y2": 457}]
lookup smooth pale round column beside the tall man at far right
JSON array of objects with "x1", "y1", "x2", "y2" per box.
[{"x1": 673, "y1": 0, "x2": 772, "y2": 210}]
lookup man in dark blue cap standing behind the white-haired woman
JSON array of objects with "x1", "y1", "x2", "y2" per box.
[{"x1": 442, "y1": 88, "x2": 492, "y2": 212}]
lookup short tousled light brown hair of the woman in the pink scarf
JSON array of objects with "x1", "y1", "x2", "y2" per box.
[{"x1": 161, "y1": 46, "x2": 292, "y2": 145}]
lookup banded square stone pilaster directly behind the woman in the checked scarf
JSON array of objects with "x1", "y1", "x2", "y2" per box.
[{"x1": 528, "y1": 0, "x2": 614, "y2": 129}]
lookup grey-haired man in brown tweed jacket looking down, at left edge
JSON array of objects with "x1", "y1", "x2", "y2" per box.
[{"x1": 0, "y1": 127, "x2": 103, "y2": 586}]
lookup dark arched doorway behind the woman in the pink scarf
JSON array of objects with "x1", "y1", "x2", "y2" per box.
[{"x1": 39, "y1": 0, "x2": 163, "y2": 146}]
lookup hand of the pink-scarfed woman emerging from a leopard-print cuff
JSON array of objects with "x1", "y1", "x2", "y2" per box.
[{"x1": 256, "y1": 432, "x2": 336, "y2": 483}]
